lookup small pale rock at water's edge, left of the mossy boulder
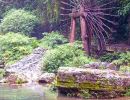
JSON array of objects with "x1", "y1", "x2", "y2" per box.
[{"x1": 38, "y1": 73, "x2": 55, "y2": 83}]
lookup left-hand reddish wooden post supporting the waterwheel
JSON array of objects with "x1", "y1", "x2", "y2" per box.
[{"x1": 69, "y1": 17, "x2": 76, "y2": 43}]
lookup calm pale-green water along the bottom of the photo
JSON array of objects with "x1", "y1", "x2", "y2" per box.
[{"x1": 0, "y1": 84, "x2": 130, "y2": 100}]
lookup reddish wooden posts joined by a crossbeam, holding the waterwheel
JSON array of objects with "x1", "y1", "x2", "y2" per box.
[{"x1": 69, "y1": 6, "x2": 91, "y2": 55}]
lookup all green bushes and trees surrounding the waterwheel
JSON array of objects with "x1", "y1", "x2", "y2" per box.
[{"x1": 0, "y1": 0, "x2": 130, "y2": 96}]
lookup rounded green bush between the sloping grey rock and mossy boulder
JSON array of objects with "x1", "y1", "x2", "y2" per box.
[{"x1": 43, "y1": 44, "x2": 92, "y2": 72}]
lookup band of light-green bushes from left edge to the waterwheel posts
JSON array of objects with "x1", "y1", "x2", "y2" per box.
[{"x1": 0, "y1": 32, "x2": 92, "y2": 72}]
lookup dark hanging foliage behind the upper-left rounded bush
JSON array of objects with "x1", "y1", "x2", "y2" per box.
[{"x1": 0, "y1": 0, "x2": 59, "y2": 23}]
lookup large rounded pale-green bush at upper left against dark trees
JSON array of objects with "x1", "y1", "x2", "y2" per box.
[{"x1": 0, "y1": 9, "x2": 38, "y2": 35}]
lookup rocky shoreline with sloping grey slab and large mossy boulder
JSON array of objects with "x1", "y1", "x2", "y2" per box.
[{"x1": 0, "y1": 47, "x2": 130, "y2": 98}]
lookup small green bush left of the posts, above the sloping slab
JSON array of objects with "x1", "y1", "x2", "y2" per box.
[{"x1": 40, "y1": 32, "x2": 68, "y2": 48}]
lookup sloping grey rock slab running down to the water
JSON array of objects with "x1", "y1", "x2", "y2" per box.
[{"x1": 6, "y1": 47, "x2": 47, "y2": 81}]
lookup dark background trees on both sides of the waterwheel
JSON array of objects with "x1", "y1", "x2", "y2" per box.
[{"x1": 0, "y1": 0, "x2": 130, "y2": 40}]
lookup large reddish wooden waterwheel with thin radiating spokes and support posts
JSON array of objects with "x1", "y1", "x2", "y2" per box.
[{"x1": 60, "y1": 0, "x2": 118, "y2": 55}]
